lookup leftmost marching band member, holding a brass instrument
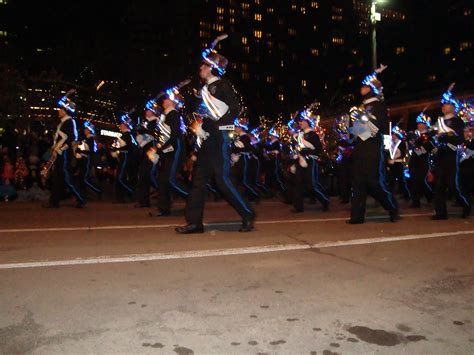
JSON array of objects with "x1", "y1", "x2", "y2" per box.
[{"x1": 43, "y1": 90, "x2": 85, "y2": 208}]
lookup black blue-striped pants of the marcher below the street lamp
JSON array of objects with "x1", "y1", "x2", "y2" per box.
[{"x1": 351, "y1": 135, "x2": 397, "y2": 221}]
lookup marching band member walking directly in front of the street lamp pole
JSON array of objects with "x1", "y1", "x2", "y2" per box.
[{"x1": 347, "y1": 65, "x2": 399, "y2": 224}]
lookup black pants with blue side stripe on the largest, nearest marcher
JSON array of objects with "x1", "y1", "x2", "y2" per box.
[{"x1": 185, "y1": 130, "x2": 254, "y2": 225}]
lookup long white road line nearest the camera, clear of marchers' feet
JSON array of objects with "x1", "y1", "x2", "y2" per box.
[{"x1": 0, "y1": 230, "x2": 474, "y2": 269}]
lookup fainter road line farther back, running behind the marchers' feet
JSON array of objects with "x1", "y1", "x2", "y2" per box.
[{"x1": 0, "y1": 213, "x2": 432, "y2": 233}]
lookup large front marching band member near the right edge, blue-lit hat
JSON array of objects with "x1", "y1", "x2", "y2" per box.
[{"x1": 432, "y1": 84, "x2": 471, "y2": 220}]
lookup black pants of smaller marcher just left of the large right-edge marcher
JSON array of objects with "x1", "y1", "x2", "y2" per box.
[{"x1": 409, "y1": 154, "x2": 433, "y2": 204}]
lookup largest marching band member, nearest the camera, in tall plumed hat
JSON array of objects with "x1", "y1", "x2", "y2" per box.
[{"x1": 176, "y1": 35, "x2": 255, "y2": 234}]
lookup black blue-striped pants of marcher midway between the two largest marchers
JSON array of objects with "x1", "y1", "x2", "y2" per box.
[{"x1": 293, "y1": 158, "x2": 329, "y2": 211}]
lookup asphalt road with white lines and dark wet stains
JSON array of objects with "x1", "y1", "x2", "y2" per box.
[{"x1": 0, "y1": 201, "x2": 474, "y2": 354}]
